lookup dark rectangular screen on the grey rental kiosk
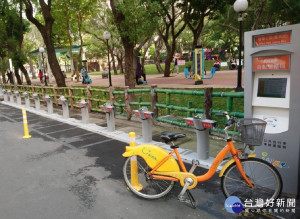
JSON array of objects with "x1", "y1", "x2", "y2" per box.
[{"x1": 257, "y1": 78, "x2": 287, "y2": 98}]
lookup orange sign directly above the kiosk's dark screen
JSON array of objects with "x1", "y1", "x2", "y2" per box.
[{"x1": 253, "y1": 55, "x2": 290, "y2": 71}]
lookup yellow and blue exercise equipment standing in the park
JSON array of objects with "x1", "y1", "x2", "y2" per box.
[{"x1": 193, "y1": 49, "x2": 216, "y2": 85}]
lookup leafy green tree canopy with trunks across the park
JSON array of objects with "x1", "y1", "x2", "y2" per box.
[{"x1": 0, "y1": 0, "x2": 300, "y2": 88}]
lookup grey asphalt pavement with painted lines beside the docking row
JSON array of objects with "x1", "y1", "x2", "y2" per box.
[{"x1": 0, "y1": 103, "x2": 298, "y2": 219}]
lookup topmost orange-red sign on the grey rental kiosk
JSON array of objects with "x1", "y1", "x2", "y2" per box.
[{"x1": 254, "y1": 31, "x2": 291, "y2": 47}]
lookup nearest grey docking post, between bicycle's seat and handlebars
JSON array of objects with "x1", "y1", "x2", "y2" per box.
[{"x1": 185, "y1": 114, "x2": 217, "y2": 160}]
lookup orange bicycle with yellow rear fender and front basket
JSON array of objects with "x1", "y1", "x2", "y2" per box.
[{"x1": 123, "y1": 113, "x2": 282, "y2": 208}]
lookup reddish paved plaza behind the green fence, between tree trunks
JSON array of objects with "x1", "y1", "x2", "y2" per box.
[{"x1": 32, "y1": 70, "x2": 244, "y2": 89}]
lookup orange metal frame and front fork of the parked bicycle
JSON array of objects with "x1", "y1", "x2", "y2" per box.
[{"x1": 149, "y1": 141, "x2": 253, "y2": 187}]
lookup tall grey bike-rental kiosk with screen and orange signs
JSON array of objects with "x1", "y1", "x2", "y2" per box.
[{"x1": 244, "y1": 24, "x2": 300, "y2": 196}]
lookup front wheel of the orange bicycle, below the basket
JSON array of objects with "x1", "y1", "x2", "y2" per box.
[{"x1": 221, "y1": 158, "x2": 282, "y2": 207}]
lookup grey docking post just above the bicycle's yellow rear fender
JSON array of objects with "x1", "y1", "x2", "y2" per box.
[{"x1": 134, "y1": 107, "x2": 154, "y2": 143}]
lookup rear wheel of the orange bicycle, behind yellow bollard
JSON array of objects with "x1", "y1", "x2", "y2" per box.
[{"x1": 123, "y1": 156, "x2": 174, "y2": 199}]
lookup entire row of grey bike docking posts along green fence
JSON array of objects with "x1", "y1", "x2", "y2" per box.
[{"x1": 0, "y1": 86, "x2": 216, "y2": 160}]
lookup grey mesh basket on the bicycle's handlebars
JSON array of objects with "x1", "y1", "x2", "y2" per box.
[{"x1": 237, "y1": 118, "x2": 267, "y2": 146}]
